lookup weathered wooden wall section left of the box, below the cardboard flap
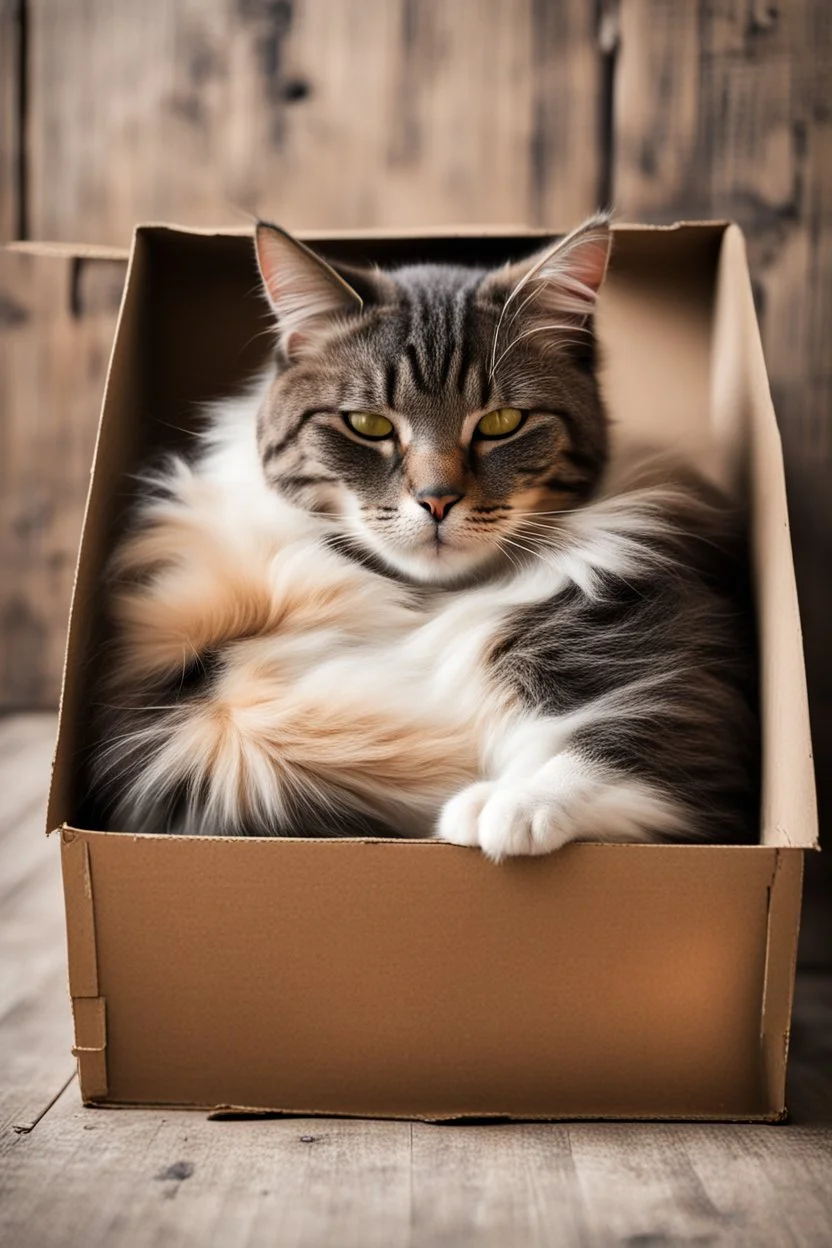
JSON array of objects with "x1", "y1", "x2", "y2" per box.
[{"x1": 0, "y1": 252, "x2": 123, "y2": 708}]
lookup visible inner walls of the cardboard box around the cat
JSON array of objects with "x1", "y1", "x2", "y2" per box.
[{"x1": 49, "y1": 225, "x2": 817, "y2": 847}]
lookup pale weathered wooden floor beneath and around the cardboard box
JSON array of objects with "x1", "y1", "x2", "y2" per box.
[{"x1": 0, "y1": 715, "x2": 832, "y2": 1248}]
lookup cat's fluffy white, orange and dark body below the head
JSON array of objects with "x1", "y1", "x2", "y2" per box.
[{"x1": 95, "y1": 386, "x2": 753, "y2": 857}]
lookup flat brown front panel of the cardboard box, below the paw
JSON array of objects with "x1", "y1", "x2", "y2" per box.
[{"x1": 69, "y1": 834, "x2": 776, "y2": 1117}]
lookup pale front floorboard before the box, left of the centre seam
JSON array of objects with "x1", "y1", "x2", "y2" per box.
[{"x1": 0, "y1": 1085, "x2": 410, "y2": 1248}]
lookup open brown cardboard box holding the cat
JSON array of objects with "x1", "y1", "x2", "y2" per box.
[{"x1": 42, "y1": 223, "x2": 816, "y2": 1121}]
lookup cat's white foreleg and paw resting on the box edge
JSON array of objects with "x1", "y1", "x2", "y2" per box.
[{"x1": 437, "y1": 720, "x2": 690, "y2": 861}]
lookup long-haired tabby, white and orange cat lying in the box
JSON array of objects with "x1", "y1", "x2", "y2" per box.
[{"x1": 94, "y1": 215, "x2": 758, "y2": 861}]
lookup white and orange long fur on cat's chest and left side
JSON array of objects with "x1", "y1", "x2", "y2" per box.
[{"x1": 101, "y1": 389, "x2": 558, "y2": 835}]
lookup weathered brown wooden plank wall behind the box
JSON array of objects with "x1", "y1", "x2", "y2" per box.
[{"x1": 0, "y1": 0, "x2": 832, "y2": 953}]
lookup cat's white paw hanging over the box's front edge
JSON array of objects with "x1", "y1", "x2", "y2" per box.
[{"x1": 437, "y1": 781, "x2": 574, "y2": 862}]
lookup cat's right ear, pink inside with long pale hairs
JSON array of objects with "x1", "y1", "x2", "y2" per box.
[{"x1": 479, "y1": 213, "x2": 612, "y2": 328}]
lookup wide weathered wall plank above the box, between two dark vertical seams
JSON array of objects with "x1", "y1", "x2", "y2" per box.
[{"x1": 29, "y1": 0, "x2": 601, "y2": 243}]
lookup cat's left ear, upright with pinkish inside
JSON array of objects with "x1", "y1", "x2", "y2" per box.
[{"x1": 254, "y1": 221, "x2": 364, "y2": 361}]
